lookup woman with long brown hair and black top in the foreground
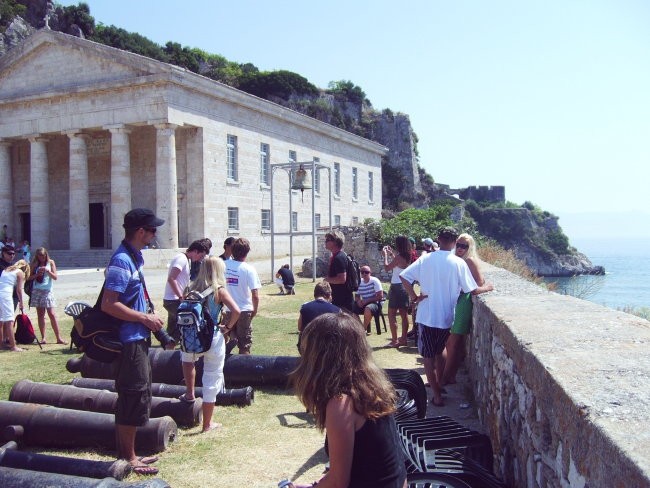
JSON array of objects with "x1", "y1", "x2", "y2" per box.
[{"x1": 291, "y1": 313, "x2": 406, "y2": 488}]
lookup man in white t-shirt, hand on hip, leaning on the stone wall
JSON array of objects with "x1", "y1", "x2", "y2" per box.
[{"x1": 400, "y1": 227, "x2": 493, "y2": 406}]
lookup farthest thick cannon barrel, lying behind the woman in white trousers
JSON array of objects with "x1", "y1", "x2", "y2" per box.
[{"x1": 66, "y1": 347, "x2": 300, "y2": 387}]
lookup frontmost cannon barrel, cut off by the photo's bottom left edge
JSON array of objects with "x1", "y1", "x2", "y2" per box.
[{"x1": 0, "y1": 466, "x2": 169, "y2": 488}]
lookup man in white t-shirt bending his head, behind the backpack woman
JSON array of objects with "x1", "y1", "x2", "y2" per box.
[{"x1": 163, "y1": 239, "x2": 210, "y2": 342}]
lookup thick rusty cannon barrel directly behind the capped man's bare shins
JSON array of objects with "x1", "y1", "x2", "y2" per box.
[{"x1": 0, "y1": 400, "x2": 178, "y2": 454}]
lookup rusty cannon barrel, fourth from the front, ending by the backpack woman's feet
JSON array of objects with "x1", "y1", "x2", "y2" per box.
[{"x1": 9, "y1": 380, "x2": 203, "y2": 427}]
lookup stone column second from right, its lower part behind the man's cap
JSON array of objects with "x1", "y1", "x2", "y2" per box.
[{"x1": 104, "y1": 125, "x2": 131, "y2": 249}]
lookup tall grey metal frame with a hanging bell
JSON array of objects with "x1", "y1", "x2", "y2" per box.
[{"x1": 271, "y1": 161, "x2": 332, "y2": 282}]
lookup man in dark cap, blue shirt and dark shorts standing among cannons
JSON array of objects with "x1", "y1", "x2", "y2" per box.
[{"x1": 101, "y1": 208, "x2": 165, "y2": 475}]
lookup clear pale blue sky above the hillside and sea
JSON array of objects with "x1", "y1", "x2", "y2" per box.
[{"x1": 60, "y1": 0, "x2": 650, "y2": 239}]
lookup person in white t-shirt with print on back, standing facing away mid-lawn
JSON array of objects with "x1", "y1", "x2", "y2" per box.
[{"x1": 224, "y1": 237, "x2": 262, "y2": 354}]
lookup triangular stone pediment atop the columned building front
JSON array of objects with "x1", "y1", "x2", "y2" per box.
[{"x1": 0, "y1": 30, "x2": 171, "y2": 100}]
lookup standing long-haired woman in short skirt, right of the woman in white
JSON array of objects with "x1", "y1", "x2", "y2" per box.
[{"x1": 28, "y1": 247, "x2": 67, "y2": 344}]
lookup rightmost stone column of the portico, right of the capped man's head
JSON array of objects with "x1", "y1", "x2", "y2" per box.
[{"x1": 154, "y1": 124, "x2": 178, "y2": 249}]
